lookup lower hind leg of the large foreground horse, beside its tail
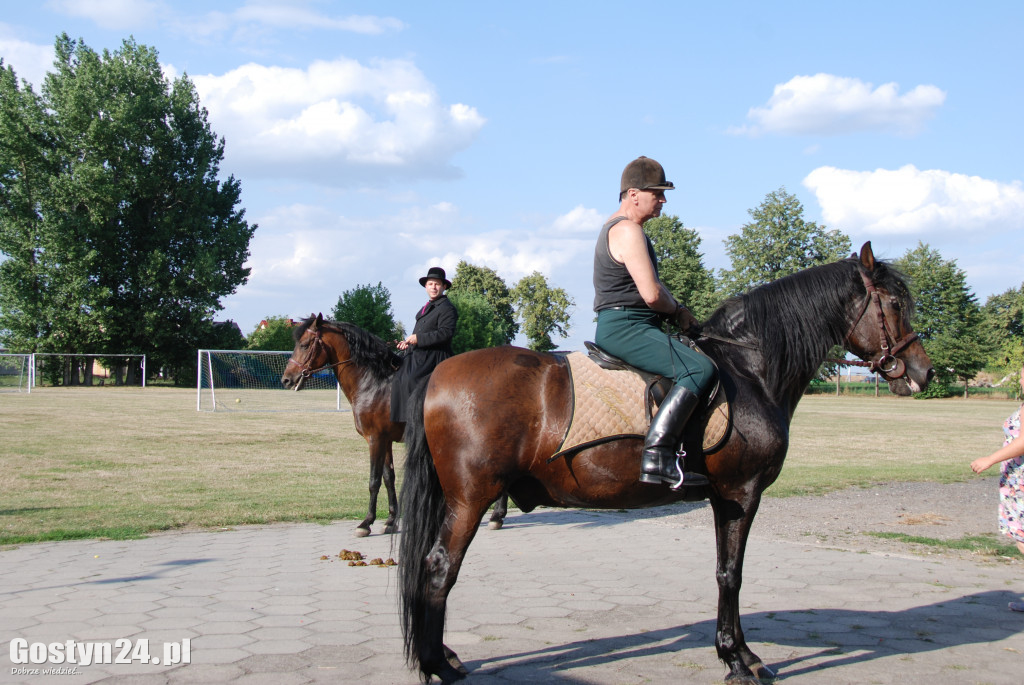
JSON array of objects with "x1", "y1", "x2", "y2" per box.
[{"x1": 420, "y1": 500, "x2": 490, "y2": 683}]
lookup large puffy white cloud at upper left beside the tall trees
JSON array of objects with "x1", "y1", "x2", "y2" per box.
[{"x1": 193, "y1": 58, "x2": 485, "y2": 185}]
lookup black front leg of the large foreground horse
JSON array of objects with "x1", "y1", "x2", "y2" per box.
[{"x1": 712, "y1": 489, "x2": 775, "y2": 685}]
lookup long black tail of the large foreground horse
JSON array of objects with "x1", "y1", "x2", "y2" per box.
[{"x1": 398, "y1": 379, "x2": 446, "y2": 679}]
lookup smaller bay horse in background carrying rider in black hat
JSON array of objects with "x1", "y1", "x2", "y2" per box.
[{"x1": 281, "y1": 314, "x2": 508, "y2": 538}]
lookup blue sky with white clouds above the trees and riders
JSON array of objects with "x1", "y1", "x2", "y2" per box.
[{"x1": 0, "y1": 0, "x2": 1024, "y2": 349}]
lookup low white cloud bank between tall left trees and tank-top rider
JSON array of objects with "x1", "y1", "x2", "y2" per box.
[{"x1": 218, "y1": 202, "x2": 601, "y2": 348}]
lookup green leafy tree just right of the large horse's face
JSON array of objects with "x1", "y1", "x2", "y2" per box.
[{"x1": 894, "y1": 242, "x2": 993, "y2": 394}]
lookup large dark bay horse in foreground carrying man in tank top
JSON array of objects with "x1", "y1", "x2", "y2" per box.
[{"x1": 398, "y1": 243, "x2": 934, "y2": 685}]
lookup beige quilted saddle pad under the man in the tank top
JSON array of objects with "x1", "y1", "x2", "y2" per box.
[{"x1": 548, "y1": 342, "x2": 730, "y2": 462}]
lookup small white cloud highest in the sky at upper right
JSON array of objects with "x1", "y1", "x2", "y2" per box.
[{"x1": 729, "y1": 74, "x2": 946, "y2": 135}]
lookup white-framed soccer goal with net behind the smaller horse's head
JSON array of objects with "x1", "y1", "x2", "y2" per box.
[{"x1": 196, "y1": 349, "x2": 348, "y2": 412}]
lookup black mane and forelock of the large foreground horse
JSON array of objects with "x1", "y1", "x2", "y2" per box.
[{"x1": 705, "y1": 253, "x2": 913, "y2": 399}]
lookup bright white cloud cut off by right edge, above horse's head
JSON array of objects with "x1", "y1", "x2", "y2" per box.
[{"x1": 804, "y1": 164, "x2": 1024, "y2": 236}]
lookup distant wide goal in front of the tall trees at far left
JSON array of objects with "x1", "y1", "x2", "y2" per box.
[{"x1": 31, "y1": 352, "x2": 145, "y2": 388}]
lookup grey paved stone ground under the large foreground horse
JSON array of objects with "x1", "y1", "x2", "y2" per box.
[{"x1": 0, "y1": 499, "x2": 1024, "y2": 685}]
